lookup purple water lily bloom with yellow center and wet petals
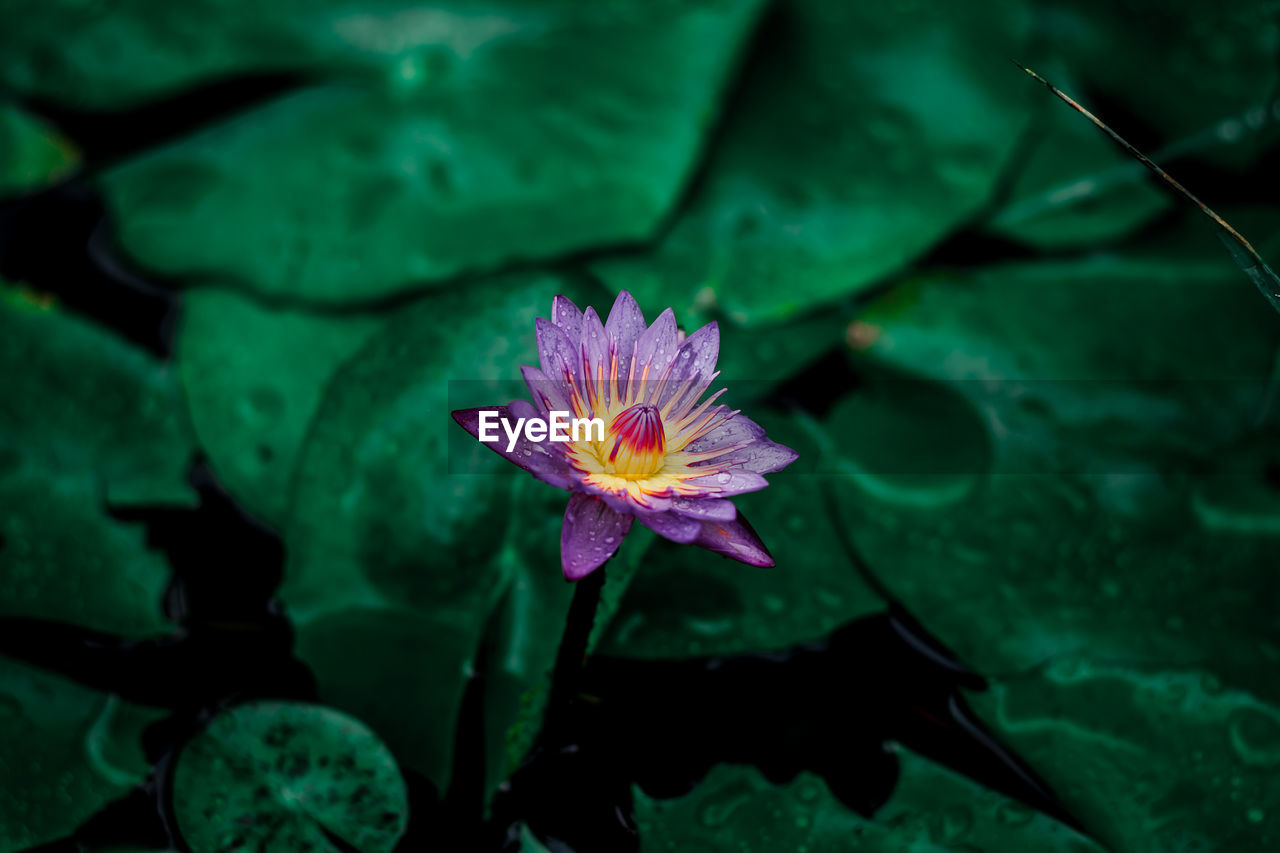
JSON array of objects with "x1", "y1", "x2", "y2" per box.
[{"x1": 453, "y1": 291, "x2": 796, "y2": 580}]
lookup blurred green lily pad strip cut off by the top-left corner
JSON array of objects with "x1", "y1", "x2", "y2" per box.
[{"x1": 0, "y1": 0, "x2": 514, "y2": 110}]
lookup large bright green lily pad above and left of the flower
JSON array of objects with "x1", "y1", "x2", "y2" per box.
[{"x1": 102, "y1": 0, "x2": 759, "y2": 304}]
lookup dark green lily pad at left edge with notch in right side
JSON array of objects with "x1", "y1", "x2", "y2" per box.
[{"x1": 0, "y1": 281, "x2": 193, "y2": 635}]
